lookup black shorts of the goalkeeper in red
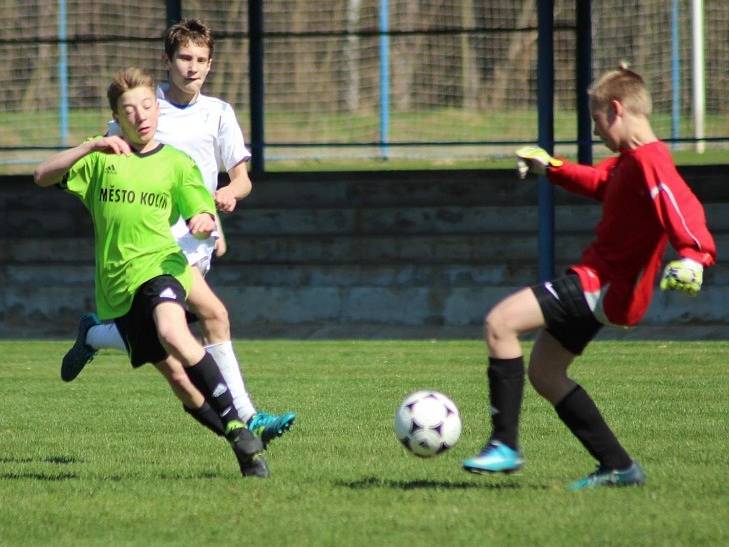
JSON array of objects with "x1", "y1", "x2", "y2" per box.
[{"x1": 532, "y1": 272, "x2": 602, "y2": 355}]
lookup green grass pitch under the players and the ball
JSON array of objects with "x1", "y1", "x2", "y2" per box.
[{"x1": 0, "y1": 340, "x2": 729, "y2": 546}]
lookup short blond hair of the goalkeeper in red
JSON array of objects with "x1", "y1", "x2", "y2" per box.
[{"x1": 587, "y1": 62, "x2": 652, "y2": 116}]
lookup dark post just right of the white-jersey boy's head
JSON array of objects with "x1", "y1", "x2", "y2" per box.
[{"x1": 248, "y1": 0, "x2": 265, "y2": 174}]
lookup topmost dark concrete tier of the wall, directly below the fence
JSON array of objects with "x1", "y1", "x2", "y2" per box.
[{"x1": 5, "y1": 165, "x2": 729, "y2": 211}]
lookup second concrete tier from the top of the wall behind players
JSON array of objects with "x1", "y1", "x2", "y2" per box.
[{"x1": 6, "y1": 203, "x2": 729, "y2": 238}]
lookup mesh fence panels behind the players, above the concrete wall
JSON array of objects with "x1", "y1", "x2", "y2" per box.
[{"x1": 0, "y1": 0, "x2": 729, "y2": 173}]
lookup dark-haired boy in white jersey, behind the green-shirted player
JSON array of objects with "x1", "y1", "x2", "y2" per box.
[{"x1": 61, "y1": 19, "x2": 295, "y2": 450}]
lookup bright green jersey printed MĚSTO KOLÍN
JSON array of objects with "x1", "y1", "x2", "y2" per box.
[{"x1": 60, "y1": 145, "x2": 215, "y2": 319}]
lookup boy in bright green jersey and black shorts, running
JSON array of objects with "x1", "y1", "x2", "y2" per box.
[{"x1": 34, "y1": 68, "x2": 269, "y2": 476}]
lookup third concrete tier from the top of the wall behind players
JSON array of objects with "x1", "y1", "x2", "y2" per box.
[{"x1": 7, "y1": 232, "x2": 729, "y2": 266}]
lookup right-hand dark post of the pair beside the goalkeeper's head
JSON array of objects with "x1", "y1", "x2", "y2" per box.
[{"x1": 575, "y1": 0, "x2": 592, "y2": 165}]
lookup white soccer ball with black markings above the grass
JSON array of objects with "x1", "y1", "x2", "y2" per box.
[{"x1": 395, "y1": 391, "x2": 461, "y2": 458}]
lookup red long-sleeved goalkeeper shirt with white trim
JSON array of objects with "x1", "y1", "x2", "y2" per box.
[{"x1": 548, "y1": 141, "x2": 716, "y2": 325}]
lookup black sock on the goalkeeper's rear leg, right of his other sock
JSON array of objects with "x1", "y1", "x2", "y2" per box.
[{"x1": 554, "y1": 385, "x2": 632, "y2": 469}]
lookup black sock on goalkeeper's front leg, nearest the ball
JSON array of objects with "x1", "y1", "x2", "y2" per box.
[{"x1": 488, "y1": 357, "x2": 524, "y2": 450}]
